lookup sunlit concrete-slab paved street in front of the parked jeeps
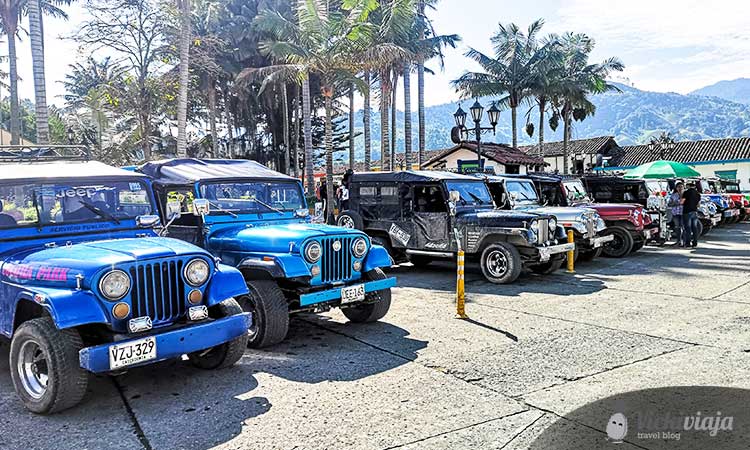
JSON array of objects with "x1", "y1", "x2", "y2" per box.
[{"x1": 0, "y1": 224, "x2": 750, "y2": 450}]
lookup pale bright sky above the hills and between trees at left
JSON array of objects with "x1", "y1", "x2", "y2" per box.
[{"x1": 14, "y1": 0, "x2": 750, "y2": 105}]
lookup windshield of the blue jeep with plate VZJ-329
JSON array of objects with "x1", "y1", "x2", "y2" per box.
[{"x1": 0, "y1": 180, "x2": 153, "y2": 228}]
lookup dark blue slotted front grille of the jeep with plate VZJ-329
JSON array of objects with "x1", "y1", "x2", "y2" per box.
[{"x1": 130, "y1": 260, "x2": 186, "y2": 325}]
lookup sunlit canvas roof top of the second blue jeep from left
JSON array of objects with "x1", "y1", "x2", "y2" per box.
[{"x1": 138, "y1": 158, "x2": 296, "y2": 184}]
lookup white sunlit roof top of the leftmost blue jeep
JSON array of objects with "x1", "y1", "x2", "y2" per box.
[{"x1": 0, "y1": 161, "x2": 151, "y2": 182}]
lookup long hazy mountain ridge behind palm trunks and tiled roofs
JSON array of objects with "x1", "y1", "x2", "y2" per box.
[{"x1": 356, "y1": 85, "x2": 750, "y2": 159}]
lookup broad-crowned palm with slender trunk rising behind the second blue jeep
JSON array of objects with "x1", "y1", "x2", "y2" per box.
[{"x1": 247, "y1": 0, "x2": 401, "y2": 221}]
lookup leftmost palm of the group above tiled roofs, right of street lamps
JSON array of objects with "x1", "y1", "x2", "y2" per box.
[{"x1": 452, "y1": 19, "x2": 549, "y2": 147}]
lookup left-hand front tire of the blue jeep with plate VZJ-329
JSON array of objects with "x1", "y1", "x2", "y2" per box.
[{"x1": 10, "y1": 317, "x2": 88, "y2": 414}]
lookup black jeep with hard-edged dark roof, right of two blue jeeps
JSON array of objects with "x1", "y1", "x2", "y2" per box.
[{"x1": 338, "y1": 171, "x2": 575, "y2": 283}]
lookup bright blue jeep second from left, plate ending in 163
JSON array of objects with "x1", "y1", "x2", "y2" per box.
[{"x1": 138, "y1": 159, "x2": 396, "y2": 348}]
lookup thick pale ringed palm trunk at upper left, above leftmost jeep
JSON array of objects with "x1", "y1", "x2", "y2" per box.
[{"x1": 26, "y1": 0, "x2": 73, "y2": 144}]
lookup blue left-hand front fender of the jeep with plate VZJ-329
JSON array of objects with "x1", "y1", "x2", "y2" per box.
[{"x1": 13, "y1": 288, "x2": 110, "y2": 330}]
